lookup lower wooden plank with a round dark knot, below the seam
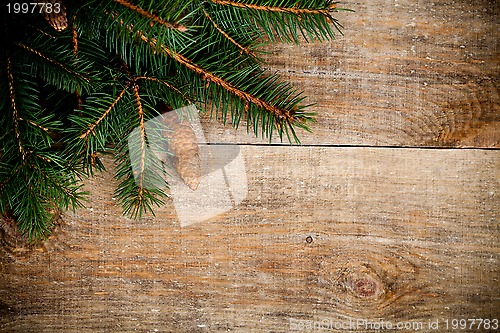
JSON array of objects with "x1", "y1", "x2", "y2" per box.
[{"x1": 0, "y1": 146, "x2": 500, "y2": 332}]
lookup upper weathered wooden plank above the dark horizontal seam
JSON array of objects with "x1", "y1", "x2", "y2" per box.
[{"x1": 200, "y1": 0, "x2": 500, "y2": 147}]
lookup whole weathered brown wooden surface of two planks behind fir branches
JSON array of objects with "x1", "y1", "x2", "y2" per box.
[{"x1": 0, "y1": 0, "x2": 500, "y2": 332}]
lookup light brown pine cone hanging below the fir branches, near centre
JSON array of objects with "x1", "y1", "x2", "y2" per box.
[{"x1": 163, "y1": 114, "x2": 201, "y2": 191}]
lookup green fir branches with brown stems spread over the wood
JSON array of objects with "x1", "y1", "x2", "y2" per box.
[{"x1": 0, "y1": 0, "x2": 346, "y2": 241}]
